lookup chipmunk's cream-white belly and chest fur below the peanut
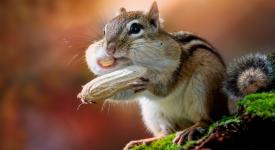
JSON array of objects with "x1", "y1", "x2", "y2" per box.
[{"x1": 139, "y1": 69, "x2": 210, "y2": 135}]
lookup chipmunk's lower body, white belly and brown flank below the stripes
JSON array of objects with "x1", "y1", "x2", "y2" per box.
[{"x1": 136, "y1": 45, "x2": 229, "y2": 136}]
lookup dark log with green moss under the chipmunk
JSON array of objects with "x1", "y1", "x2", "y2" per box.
[{"x1": 133, "y1": 93, "x2": 275, "y2": 150}]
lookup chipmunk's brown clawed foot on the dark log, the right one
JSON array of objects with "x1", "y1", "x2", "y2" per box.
[{"x1": 173, "y1": 121, "x2": 209, "y2": 144}]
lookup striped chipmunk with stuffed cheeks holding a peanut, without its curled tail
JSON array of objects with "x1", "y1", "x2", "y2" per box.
[{"x1": 86, "y1": 2, "x2": 274, "y2": 149}]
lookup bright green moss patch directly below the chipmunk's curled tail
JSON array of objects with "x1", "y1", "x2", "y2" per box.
[{"x1": 238, "y1": 93, "x2": 275, "y2": 121}]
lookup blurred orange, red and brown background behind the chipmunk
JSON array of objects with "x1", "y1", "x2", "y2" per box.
[{"x1": 0, "y1": 0, "x2": 275, "y2": 150}]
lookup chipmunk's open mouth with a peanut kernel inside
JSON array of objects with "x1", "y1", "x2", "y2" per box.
[{"x1": 97, "y1": 57, "x2": 129, "y2": 69}]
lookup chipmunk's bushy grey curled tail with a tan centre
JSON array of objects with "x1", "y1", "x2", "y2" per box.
[{"x1": 223, "y1": 53, "x2": 275, "y2": 100}]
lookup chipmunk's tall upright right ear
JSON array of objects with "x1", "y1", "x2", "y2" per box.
[{"x1": 147, "y1": 1, "x2": 160, "y2": 28}]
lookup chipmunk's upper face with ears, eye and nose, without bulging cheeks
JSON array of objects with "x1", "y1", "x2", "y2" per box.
[{"x1": 104, "y1": 2, "x2": 160, "y2": 57}]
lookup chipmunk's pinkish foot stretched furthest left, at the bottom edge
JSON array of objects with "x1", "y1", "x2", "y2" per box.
[{"x1": 123, "y1": 134, "x2": 165, "y2": 150}]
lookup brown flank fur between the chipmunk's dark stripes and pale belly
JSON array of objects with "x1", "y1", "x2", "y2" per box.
[{"x1": 175, "y1": 49, "x2": 231, "y2": 119}]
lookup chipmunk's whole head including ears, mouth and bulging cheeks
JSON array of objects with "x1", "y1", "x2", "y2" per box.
[{"x1": 86, "y1": 2, "x2": 181, "y2": 74}]
